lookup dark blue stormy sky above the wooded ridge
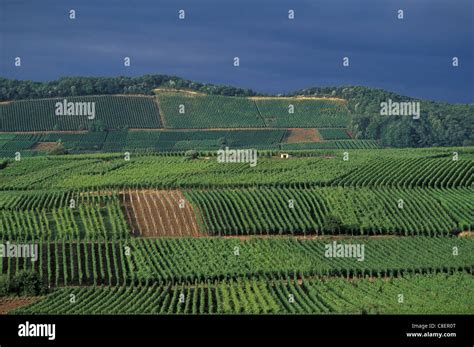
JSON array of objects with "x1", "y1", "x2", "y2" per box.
[{"x1": 0, "y1": 0, "x2": 474, "y2": 103}]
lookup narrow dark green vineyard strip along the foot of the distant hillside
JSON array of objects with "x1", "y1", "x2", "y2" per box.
[{"x1": 0, "y1": 129, "x2": 368, "y2": 154}]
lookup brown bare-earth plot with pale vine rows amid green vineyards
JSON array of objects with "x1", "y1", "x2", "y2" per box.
[{"x1": 122, "y1": 190, "x2": 200, "y2": 237}]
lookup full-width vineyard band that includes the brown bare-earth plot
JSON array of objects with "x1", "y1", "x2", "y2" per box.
[{"x1": 0, "y1": 187, "x2": 474, "y2": 240}]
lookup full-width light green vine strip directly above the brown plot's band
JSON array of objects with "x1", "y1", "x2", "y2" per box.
[{"x1": 0, "y1": 149, "x2": 473, "y2": 190}]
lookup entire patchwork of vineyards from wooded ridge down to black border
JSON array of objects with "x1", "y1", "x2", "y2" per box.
[{"x1": 0, "y1": 104, "x2": 474, "y2": 314}]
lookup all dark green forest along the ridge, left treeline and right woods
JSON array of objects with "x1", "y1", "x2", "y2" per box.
[{"x1": 0, "y1": 75, "x2": 474, "y2": 147}]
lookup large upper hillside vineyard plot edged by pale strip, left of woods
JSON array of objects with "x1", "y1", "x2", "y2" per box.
[{"x1": 157, "y1": 93, "x2": 349, "y2": 129}]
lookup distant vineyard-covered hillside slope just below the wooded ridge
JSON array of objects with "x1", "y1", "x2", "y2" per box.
[{"x1": 0, "y1": 89, "x2": 366, "y2": 157}]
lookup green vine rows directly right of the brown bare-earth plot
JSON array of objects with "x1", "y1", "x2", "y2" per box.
[{"x1": 185, "y1": 187, "x2": 474, "y2": 235}]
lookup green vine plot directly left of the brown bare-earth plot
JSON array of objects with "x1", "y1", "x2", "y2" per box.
[{"x1": 0, "y1": 192, "x2": 130, "y2": 242}]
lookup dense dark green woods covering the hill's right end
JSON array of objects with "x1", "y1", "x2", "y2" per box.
[{"x1": 292, "y1": 86, "x2": 474, "y2": 147}]
